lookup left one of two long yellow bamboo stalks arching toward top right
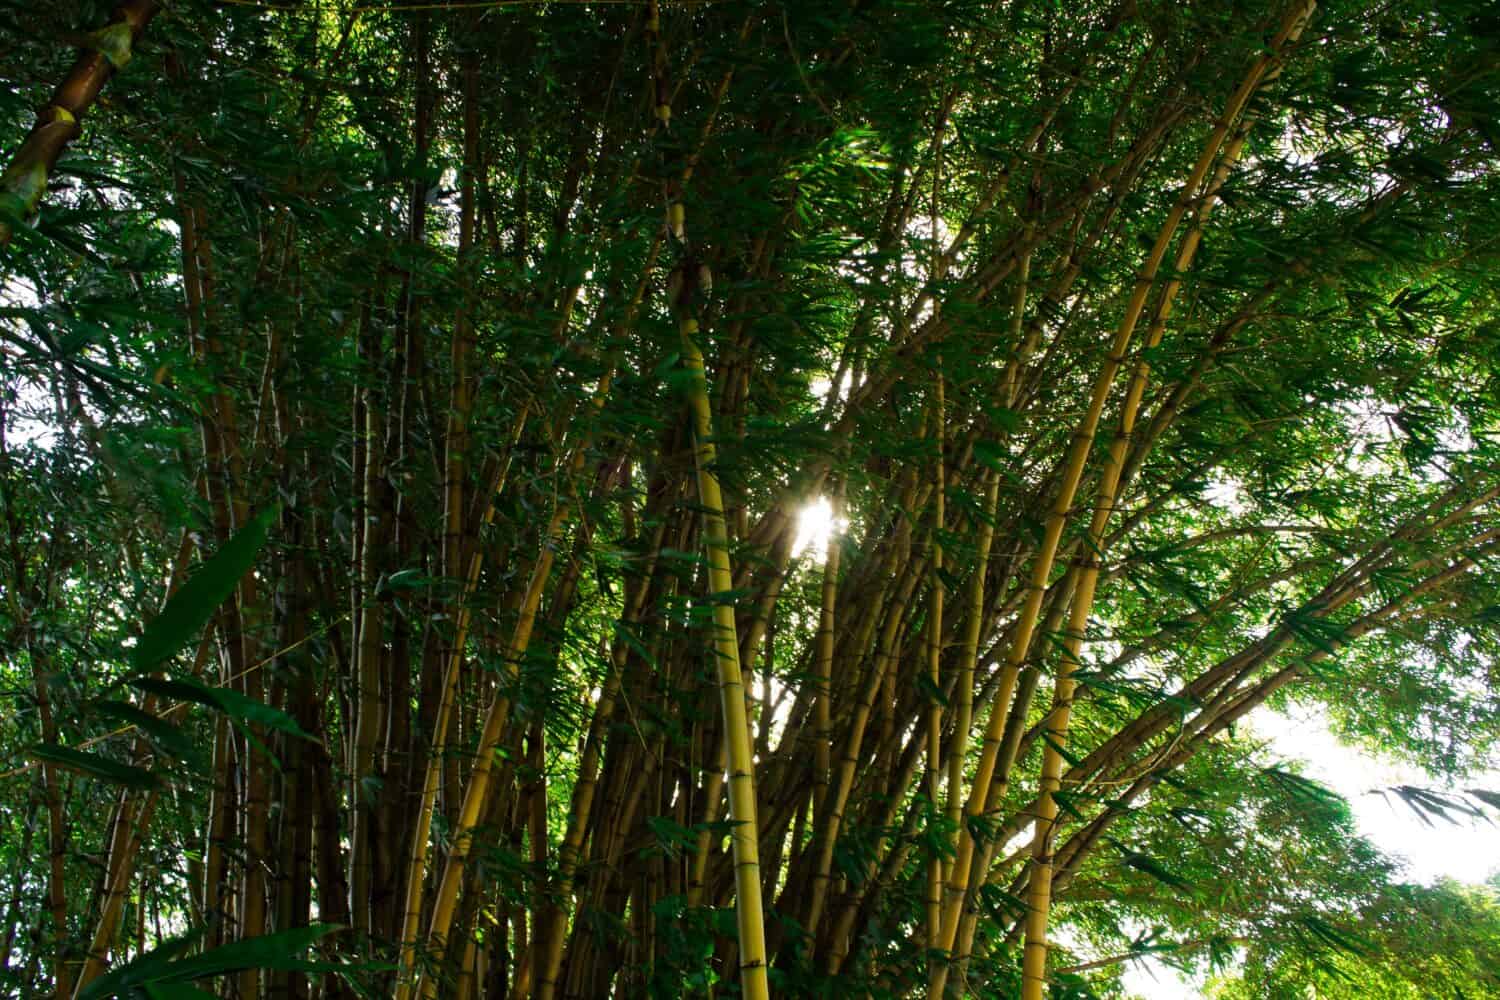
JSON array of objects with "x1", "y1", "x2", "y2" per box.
[{"x1": 936, "y1": 0, "x2": 1311, "y2": 977}]
